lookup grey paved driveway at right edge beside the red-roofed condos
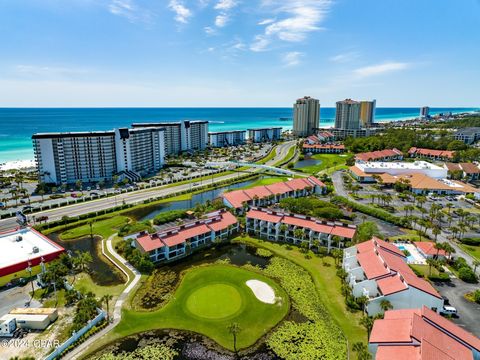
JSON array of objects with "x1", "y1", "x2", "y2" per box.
[{"x1": 433, "y1": 279, "x2": 480, "y2": 337}]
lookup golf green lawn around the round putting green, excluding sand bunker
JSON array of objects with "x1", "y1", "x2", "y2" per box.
[{"x1": 109, "y1": 265, "x2": 290, "y2": 350}]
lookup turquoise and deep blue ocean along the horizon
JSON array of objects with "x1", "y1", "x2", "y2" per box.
[{"x1": 0, "y1": 107, "x2": 478, "y2": 163}]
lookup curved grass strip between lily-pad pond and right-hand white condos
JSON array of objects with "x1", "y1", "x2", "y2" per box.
[{"x1": 233, "y1": 237, "x2": 367, "y2": 353}]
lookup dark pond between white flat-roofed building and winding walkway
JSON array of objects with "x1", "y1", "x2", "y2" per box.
[{"x1": 48, "y1": 233, "x2": 125, "y2": 286}]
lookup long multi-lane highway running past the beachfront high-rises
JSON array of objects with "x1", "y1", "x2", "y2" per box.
[{"x1": 0, "y1": 141, "x2": 295, "y2": 231}]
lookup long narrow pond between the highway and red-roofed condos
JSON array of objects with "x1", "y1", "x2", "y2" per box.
[{"x1": 137, "y1": 177, "x2": 262, "y2": 221}]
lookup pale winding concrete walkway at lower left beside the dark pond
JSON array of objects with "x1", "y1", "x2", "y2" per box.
[{"x1": 63, "y1": 234, "x2": 141, "y2": 359}]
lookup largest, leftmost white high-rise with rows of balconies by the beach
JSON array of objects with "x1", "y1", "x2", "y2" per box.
[{"x1": 32, "y1": 128, "x2": 165, "y2": 184}]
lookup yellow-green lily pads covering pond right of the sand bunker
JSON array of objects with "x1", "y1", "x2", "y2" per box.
[{"x1": 264, "y1": 257, "x2": 347, "y2": 360}]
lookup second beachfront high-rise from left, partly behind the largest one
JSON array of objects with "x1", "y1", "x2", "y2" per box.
[{"x1": 132, "y1": 120, "x2": 208, "y2": 155}]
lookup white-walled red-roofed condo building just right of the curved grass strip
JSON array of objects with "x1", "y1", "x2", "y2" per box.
[{"x1": 343, "y1": 237, "x2": 443, "y2": 316}]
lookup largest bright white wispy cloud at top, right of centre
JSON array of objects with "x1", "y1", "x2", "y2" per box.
[{"x1": 251, "y1": 0, "x2": 332, "y2": 51}]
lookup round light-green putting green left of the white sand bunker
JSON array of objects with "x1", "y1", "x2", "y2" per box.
[{"x1": 185, "y1": 284, "x2": 243, "y2": 319}]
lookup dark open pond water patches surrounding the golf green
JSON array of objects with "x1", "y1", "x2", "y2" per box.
[{"x1": 87, "y1": 243, "x2": 307, "y2": 360}]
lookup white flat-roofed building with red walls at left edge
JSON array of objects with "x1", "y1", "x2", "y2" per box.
[{"x1": 0, "y1": 227, "x2": 64, "y2": 277}]
